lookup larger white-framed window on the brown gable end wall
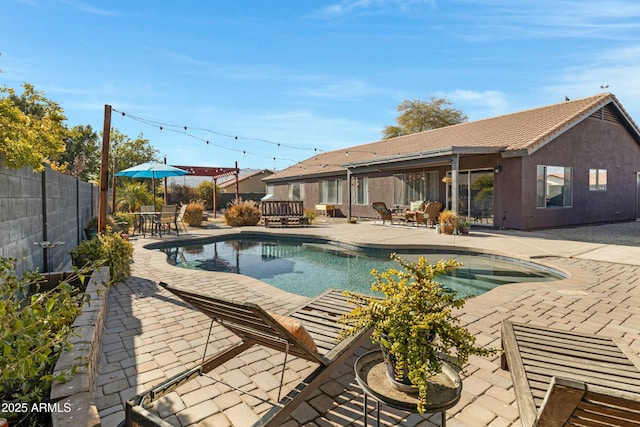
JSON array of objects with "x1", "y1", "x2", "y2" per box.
[{"x1": 536, "y1": 165, "x2": 573, "y2": 208}]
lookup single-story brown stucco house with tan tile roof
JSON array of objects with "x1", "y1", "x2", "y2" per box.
[{"x1": 264, "y1": 93, "x2": 640, "y2": 230}]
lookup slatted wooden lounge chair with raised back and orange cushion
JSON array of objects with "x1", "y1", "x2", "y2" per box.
[{"x1": 125, "y1": 283, "x2": 370, "y2": 427}]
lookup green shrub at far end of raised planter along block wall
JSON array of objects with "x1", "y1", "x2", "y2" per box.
[{"x1": 69, "y1": 231, "x2": 133, "y2": 282}]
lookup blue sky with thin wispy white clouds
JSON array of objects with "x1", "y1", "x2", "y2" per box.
[{"x1": 0, "y1": 0, "x2": 640, "y2": 169}]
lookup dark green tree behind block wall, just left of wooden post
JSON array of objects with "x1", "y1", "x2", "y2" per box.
[{"x1": 58, "y1": 125, "x2": 101, "y2": 181}]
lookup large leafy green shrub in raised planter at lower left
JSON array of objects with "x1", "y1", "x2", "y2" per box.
[{"x1": 0, "y1": 258, "x2": 86, "y2": 426}]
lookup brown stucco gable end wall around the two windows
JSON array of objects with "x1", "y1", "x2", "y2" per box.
[{"x1": 516, "y1": 118, "x2": 640, "y2": 229}]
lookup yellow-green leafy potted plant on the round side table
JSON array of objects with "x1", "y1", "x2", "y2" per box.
[{"x1": 339, "y1": 254, "x2": 497, "y2": 413}]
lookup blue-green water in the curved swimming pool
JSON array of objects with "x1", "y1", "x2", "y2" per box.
[{"x1": 161, "y1": 237, "x2": 564, "y2": 296}]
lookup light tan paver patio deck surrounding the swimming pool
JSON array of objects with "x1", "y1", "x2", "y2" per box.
[{"x1": 95, "y1": 221, "x2": 640, "y2": 427}]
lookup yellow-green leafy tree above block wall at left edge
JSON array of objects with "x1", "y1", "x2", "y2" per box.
[{"x1": 0, "y1": 83, "x2": 67, "y2": 171}]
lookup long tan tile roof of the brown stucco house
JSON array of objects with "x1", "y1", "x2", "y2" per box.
[{"x1": 265, "y1": 93, "x2": 640, "y2": 181}]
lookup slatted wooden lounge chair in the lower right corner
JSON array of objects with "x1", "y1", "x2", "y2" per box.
[{"x1": 502, "y1": 321, "x2": 640, "y2": 427}]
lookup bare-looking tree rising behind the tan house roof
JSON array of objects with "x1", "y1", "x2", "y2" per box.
[{"x1": 382, "y1": 97, "x2": 467, "y2": 139}]
